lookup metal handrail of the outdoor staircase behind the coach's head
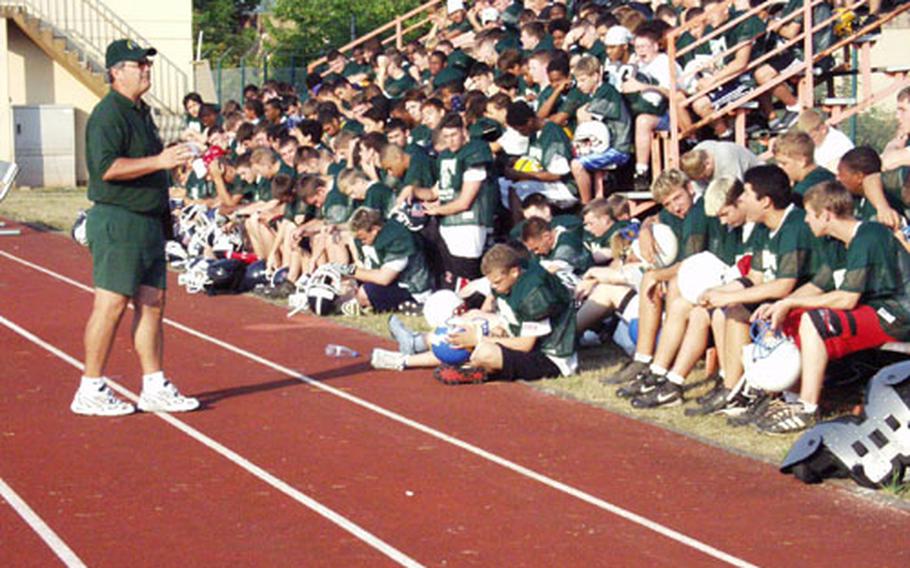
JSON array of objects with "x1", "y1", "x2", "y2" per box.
[{"x1": 0, "y1": 0, "x2": 189, "y2": 115}]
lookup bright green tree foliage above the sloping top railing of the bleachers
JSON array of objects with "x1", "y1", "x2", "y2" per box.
[{"x1": 268, "y1": 0, "x2": 423, "y2": 62}]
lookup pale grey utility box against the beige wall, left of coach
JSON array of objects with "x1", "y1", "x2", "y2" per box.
[{"x1": 13, "y1": 105, "x2": 76, "y2": 187}]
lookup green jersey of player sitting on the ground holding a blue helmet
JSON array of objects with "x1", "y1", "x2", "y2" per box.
[{"x1": 493, "y1": 261, "x2": 575, "y2": 374}]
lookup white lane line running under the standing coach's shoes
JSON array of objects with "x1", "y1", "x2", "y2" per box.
[{"x1": 0, "y1": 315, "x2": 422, "y2": 568}]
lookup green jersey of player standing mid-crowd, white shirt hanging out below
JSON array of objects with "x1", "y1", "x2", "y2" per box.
[{"x1": 436, "y1": 140, "x2": 499, "y2": 227}]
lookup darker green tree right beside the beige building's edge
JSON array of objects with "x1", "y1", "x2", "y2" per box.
[{"x1": 193, "y1": 0, "x2": 259, "y2": 65}]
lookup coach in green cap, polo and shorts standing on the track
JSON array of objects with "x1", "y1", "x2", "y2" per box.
[{"x1": 70, "y1": 39, "x2": 199, "y2": 416}]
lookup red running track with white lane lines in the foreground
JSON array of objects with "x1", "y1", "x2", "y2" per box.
[{"x1": 0, "y1": 223, "x2": 910, "y2": 565}]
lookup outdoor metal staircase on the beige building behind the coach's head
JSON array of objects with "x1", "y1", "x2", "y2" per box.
[{"x1": 0, "y1": 0, "x2": 190, "y2": 137}]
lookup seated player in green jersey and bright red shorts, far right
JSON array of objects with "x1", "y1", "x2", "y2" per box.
[{"x1": 754, "y1": 181, "x2": 910, "y2": 434}]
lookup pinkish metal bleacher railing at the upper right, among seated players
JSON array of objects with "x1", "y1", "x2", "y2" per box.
[{"x1": 664, "y1": 0, "x2": 910, "y2": 167}]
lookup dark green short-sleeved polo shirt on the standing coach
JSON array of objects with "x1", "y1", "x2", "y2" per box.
[{"x1": 85, "y1": 89, "x2": 170, "y2": 215}]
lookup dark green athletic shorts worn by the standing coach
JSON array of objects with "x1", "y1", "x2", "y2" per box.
[{"x1": 85, "y1": 203, "x2": 167, "y2": 297}]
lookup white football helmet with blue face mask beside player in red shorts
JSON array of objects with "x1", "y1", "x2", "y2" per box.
[{"x1": 743, "y1": 320, "x2": 802, "y2": 392}]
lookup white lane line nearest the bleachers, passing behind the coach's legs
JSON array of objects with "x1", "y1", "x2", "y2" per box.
[{"x1": 0, "y1": 250, "x2": 754, "y2": 567}]
